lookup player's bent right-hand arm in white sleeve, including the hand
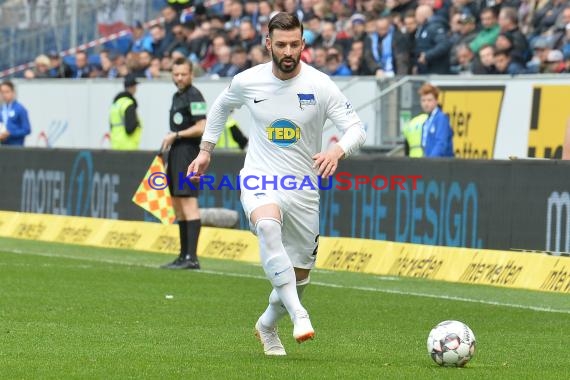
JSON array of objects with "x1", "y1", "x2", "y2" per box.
[{"x1": 313, "y1": 80, "x2": 366, "y2": 178}]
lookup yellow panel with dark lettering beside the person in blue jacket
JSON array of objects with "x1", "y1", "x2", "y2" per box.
[{"x1": 439, "y1": 86, "x2": 505, "y2": 159}]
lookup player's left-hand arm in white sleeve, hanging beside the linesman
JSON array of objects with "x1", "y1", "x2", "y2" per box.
[{"x1": 187, "y1": 77, "x2": 243, "y2": 180}]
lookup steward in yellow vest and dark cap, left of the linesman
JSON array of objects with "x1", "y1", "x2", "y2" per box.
[{"x1": 109, "y1": 74, "x2": 142, "y2": 150}]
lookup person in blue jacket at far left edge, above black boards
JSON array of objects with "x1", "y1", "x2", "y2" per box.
[{"x1": 0, "y1": 80, "x2": 31, "y2": 146}]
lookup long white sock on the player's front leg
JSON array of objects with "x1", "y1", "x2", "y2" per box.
[{"x1": 256, "y1": 218, "x2": 305, "y2": 327}]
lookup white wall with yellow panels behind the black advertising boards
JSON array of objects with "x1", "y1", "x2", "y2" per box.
[{"x1": 10, "y1": 76, "x2": 570, "y2": 158}]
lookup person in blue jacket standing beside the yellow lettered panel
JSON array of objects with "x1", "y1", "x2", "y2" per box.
[{"x1": 418, "y1": 83, "x2": 455, "y2": 157}]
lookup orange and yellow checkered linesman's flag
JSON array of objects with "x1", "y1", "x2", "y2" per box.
[{"x1": 133, "y1": 155, "x2": 176, "y2": 224}]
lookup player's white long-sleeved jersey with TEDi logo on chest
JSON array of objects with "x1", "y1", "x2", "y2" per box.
[{"x1": 202, "y1": 62, "x2": 364, "y2": 187}]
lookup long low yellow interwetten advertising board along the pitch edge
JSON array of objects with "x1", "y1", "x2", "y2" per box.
[{"x1": 0, "y1": 211, "x2": 570, "y2": 293}]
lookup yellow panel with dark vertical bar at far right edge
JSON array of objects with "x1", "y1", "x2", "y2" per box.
[{"x1": 528, "y1": 86, "x2": 570, "y2": 158}]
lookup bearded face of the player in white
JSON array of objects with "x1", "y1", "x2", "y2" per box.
[{"x1": 270, "y1": 30, "x2": 305, "y2": 73}]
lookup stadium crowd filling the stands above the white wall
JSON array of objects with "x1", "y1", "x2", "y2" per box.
[{"x1": 23, "y1": 0, "x2": 570, "y2": 79}]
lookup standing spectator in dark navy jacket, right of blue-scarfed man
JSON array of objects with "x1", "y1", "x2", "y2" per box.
[{"x1": 415, "y1": 5, "x2": 451, "y2": 74}]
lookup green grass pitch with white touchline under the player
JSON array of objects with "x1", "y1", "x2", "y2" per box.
[{"x1": 0, "y1": 238, "x2": 570, "y2": 379}]
